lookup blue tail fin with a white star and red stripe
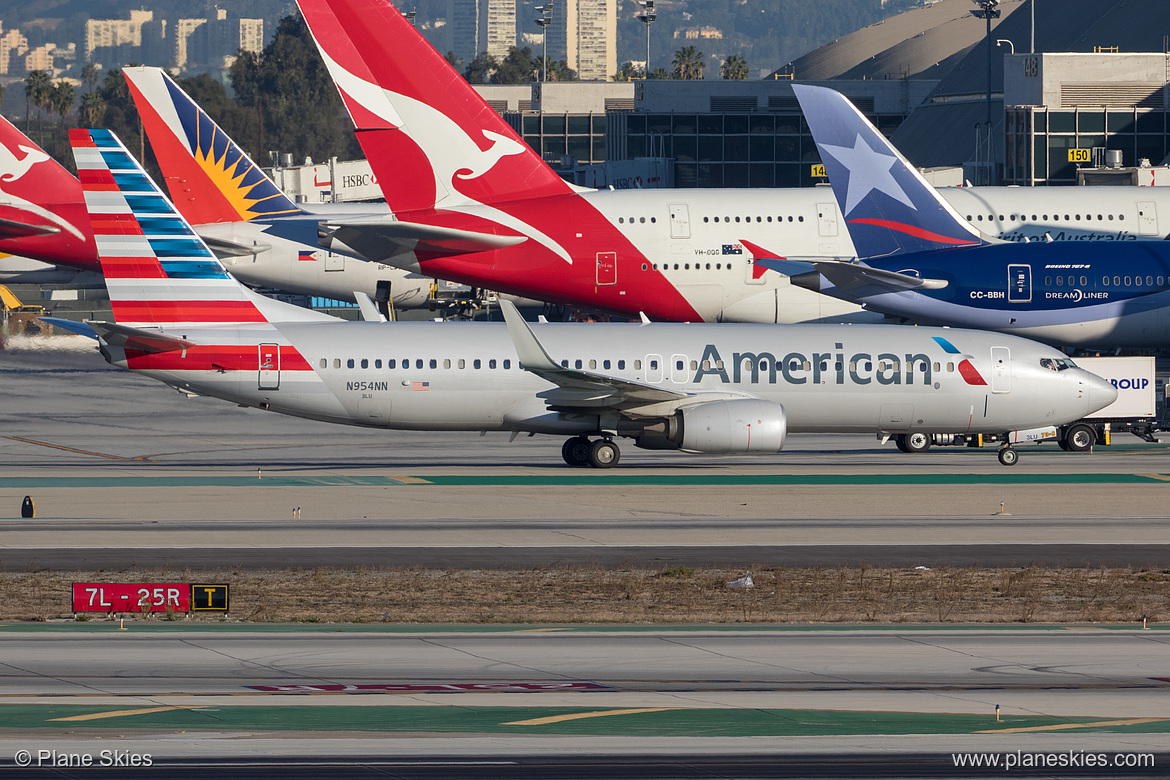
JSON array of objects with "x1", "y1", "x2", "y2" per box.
[{"x1": 792, "y1": 84, "x2": 987, "y2": 258}]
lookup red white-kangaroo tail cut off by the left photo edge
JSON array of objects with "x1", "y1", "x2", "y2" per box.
[{"x1": 0, "y1": 117, "x2": 97, "y2": 270}]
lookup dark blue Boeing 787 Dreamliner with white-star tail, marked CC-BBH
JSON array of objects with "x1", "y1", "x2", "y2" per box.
[{"x1": 744, "y1": 84, "x2": 1170, "y2": 347}]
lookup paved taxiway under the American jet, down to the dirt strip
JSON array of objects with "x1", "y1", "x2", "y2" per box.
[{"x1": 0, "y1": 337, "x2": 1170, "y2": 570}]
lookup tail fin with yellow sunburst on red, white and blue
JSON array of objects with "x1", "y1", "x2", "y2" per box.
[{"x1": 122, "y1": 67, "x2": 302, "y2": 225}]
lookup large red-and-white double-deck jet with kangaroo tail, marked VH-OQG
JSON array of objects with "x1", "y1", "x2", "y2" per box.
[{"x1": 298, "y1": 0, "x2": 1170, "y2": 323}]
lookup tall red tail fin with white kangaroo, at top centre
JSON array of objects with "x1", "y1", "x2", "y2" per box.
[{"x1": 297, "y1": 0, "x2": 572, "y2": 212}]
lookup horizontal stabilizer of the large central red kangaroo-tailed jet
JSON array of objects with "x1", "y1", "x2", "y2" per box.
[{"x1": 318, "y1": 220, "x2": 528, "y2": 264}]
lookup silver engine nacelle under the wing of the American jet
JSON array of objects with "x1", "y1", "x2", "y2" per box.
[{"x1": 675, "y1": 398, "x2": 789, "y2": 455}]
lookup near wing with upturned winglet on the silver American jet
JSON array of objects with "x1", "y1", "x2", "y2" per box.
[{"x1": 500, "y1": 301, "x2": 695, "y2": 413}]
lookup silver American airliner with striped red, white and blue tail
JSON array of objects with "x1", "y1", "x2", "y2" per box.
[{"x1": 70, "y1": 130, "x2": 1116, "y2": 468}]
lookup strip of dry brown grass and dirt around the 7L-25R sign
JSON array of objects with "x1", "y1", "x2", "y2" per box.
[{"x1": 0, "y1": 566, "x2": 1170, "y2": 623}]
